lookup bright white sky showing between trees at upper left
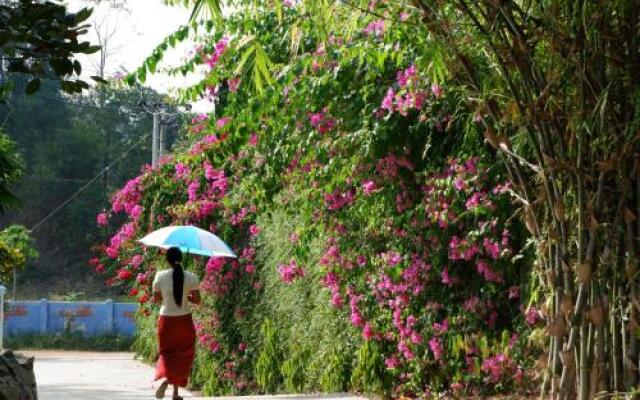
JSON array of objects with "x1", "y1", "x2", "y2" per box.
[{"x1": 66, "y1": 0, "x2": 210, "y2": 111}]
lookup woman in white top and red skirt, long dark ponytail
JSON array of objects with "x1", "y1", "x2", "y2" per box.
[{"x1": 153, "y1": 247, "x2": 200, "y2": 400}]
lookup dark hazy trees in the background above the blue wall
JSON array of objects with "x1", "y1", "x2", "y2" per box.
[{"x1": 0, "y1": 76, "x2": 170, "y2": 299}]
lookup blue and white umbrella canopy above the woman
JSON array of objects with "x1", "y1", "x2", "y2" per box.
[{"x1": 139, "y1": 226, "x2": 238, "y2": 258}]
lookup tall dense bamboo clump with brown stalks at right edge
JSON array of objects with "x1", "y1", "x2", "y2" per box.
[{"x1": 413, "y1": 0, "x2": 640, "y2": 399}]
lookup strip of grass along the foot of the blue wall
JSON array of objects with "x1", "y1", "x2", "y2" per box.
[{"x1": 4, "y1": 333, "x2": 133, "y2": 351}]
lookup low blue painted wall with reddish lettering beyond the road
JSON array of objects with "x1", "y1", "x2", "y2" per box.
[{"x1": 4, "y1": 300, "x2": 138, "y2": 336}]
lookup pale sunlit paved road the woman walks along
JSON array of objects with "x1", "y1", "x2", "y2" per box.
[{"x1": 22, "y1": 351, "x2": 364, "y2": 400}]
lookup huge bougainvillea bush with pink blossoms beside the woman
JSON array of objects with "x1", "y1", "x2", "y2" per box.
[{"x1": 92, "y1": 5, "x2": 539, "y2": 397}]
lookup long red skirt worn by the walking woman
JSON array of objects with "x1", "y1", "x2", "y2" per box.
[{"x1": 156, "y1": 314, "x2": 196, "y2": 387}]
